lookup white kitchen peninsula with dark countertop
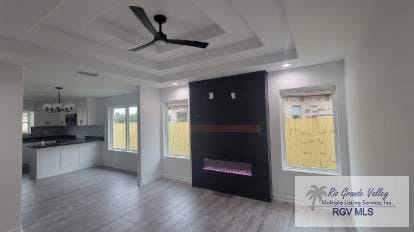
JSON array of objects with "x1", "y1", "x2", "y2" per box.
[{"x1": 25, "y1": 138, "x2": 102, "y2": 179}]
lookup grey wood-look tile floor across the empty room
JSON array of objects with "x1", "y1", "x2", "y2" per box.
[{"x1": 22, "y1": 168, "x2": 354, "y2": 232}]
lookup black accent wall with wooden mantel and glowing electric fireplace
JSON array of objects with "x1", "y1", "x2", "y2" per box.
[{"x1": 190, "y1": 71, "x2": 272, "y2": 201}]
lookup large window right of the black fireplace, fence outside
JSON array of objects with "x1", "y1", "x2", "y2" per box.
[{"x1": 281, "y1": 87, "x2": 340, "y2": 174}]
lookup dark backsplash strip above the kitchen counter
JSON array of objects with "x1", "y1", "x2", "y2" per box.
[{"x1": 29, "y1": 125, "x2": 104, "y2": 138}]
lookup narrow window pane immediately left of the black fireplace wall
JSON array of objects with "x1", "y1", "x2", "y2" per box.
[{"x1": 165, "y1": 103, "x2": 190, "y2": 158}]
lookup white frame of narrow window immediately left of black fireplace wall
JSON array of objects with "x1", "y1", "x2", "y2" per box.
[{"x1": 162, "y1": 100, "x2": 191, "y2": 160}]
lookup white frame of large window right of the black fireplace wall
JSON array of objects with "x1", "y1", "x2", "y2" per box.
[{"x1": 279, "y1": 85, "x2": 343, "y2": 176}]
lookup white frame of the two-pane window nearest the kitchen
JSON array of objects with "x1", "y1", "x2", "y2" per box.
[{"x1": 108, "y1": 104, "x2": 140, "y2": 154}]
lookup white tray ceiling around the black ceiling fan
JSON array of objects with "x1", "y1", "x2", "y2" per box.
[{"x1": 0, "y1": 0, "x2": 374, "y2": 98}]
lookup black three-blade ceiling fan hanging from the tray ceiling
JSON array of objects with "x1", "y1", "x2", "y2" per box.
[{"x1": 129, "y1": 6, "x2": 208, "y2": 52}]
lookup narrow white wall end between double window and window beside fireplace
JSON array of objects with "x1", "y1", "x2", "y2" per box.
[{"x1": 138, "y1": 87, "x2": 162, "y2": 185}]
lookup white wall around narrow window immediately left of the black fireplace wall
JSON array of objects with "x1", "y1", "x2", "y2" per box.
[{"x1": 161, "y1": 86, "x2": 192, "y2": 183}]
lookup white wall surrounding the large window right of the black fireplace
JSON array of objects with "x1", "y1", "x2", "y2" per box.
[{"x1": 268, "y1": 61, "x2": 349, "y2": 200}]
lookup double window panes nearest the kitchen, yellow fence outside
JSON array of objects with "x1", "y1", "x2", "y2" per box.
[{"x1": 109, "y1": 106, "x2": 138, "y2": 153}]
